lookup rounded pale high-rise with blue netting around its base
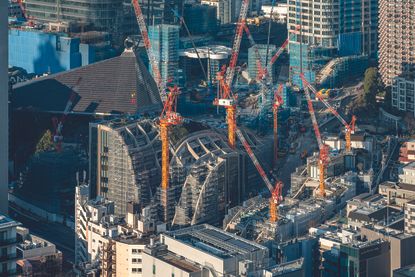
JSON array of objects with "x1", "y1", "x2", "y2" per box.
[{"x1": 288, "y1": 0, "x2": 378, "y2": 86}]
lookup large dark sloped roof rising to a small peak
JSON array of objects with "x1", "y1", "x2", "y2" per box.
[{"x1": 12, "y1": 51, "x2": 161, "y2": 113}]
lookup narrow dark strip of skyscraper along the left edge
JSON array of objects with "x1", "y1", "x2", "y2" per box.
[{"x1": 0, "y1": 1, "x2": 9, "y2": 213}]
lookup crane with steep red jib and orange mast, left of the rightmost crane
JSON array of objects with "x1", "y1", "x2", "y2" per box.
[{"x1": 300, "y1": 73, "x2": 329, "y2": 197}]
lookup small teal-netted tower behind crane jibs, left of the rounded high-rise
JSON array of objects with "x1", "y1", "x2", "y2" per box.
[{"x1": 248, "y1": 44, "x2": 277, "y2": 82}]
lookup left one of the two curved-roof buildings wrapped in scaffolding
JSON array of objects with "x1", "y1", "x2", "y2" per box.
[{"x1": 89, "y1": 117, "x2": 160, "y2": 216}]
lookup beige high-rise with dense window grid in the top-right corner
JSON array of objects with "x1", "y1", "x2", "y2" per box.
[{"x1": 379, "y1": 0, "x2": 415, "y2": 85}]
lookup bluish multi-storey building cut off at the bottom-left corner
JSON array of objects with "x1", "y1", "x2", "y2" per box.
[{"x1": 0, "y1": 214, "x2": 20, "y2": 276}]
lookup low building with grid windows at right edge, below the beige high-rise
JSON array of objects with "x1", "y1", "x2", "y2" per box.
[{"x1": 392, "y1": 75, "x2": 415, "y2": 113}]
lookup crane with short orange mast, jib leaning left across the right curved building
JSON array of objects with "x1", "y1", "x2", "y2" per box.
[{"x1": 236, "y1": 129, "x2": 283, "y2": 223}]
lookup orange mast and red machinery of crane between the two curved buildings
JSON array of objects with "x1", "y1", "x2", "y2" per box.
[{"x1": 160, "y1": 86, "x2": 183, "y2": 220}]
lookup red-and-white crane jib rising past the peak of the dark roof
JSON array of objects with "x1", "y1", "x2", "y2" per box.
[{"x1": 132, "y1": 0, "x2": 167, "y2": 102}]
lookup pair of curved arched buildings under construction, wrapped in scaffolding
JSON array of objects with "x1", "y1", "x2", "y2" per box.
[{"x1": 90, "y1": 118, "x2": 271, "y2": 226}]
